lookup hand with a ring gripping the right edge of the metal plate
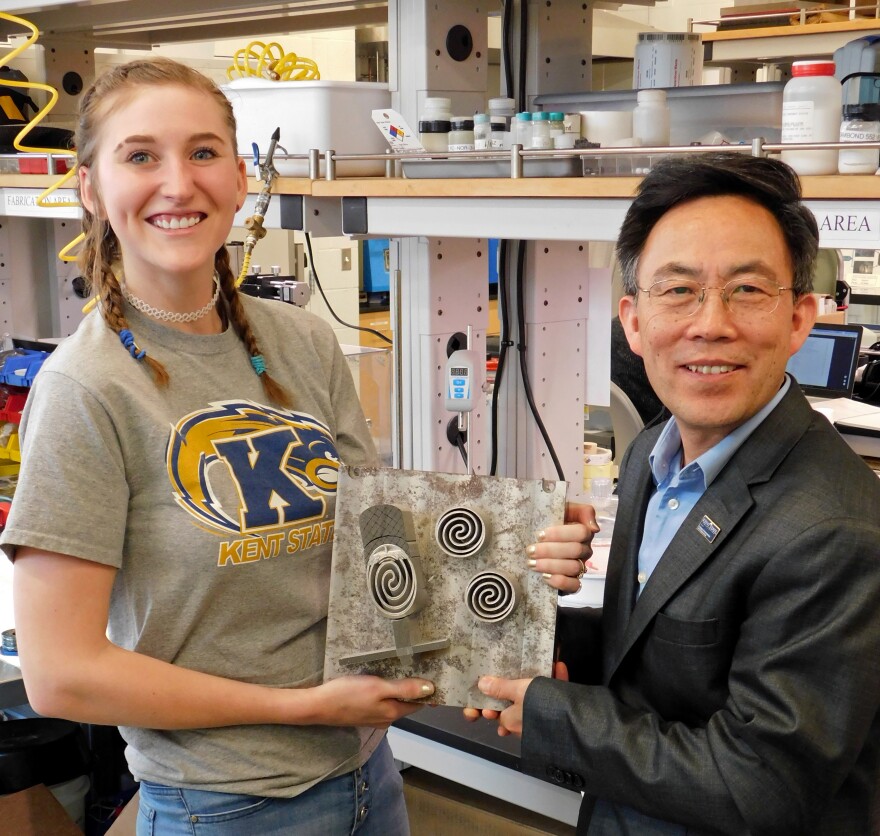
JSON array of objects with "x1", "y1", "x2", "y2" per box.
[{"x1": 526, "y1": 503, "x2": 599, "y2": 592}]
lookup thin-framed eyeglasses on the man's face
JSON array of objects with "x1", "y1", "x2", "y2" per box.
[{"x1": 639, "y1": 276, "x2": 792, "y2": 318}]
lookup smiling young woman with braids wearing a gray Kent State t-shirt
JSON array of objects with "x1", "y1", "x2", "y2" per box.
[{"x1": 2, "y1": 60, "x2": 433, "y2": 836}]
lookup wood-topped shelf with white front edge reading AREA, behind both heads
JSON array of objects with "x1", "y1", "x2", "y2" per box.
[{"x1": 0, "y1": 174, "x2": 880, "y2": 249}]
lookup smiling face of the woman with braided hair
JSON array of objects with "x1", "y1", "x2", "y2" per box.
[{"x1": 79, "y1": 84, "x2": 247, "y2": 292}]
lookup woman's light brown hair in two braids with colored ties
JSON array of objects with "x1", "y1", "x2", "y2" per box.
[{"x1": 75, "y1": 58, "x2": 291, "y2": 407}]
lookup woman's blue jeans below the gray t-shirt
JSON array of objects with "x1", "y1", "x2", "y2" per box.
[{"x1": 137, "y1": 740, "x2": 409, "y2": 836}]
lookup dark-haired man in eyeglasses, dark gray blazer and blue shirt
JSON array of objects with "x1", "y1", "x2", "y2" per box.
[{"x1": 480, "y1": 153, "x2": 880, "y2": 836}]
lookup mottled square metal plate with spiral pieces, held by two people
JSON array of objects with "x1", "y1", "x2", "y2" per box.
[{"x1": 324, "y1": 467, "x2": 566, "y2": 708}]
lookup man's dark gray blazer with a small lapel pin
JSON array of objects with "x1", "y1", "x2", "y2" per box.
[{"x1": 522, "y1": 384, "x2": 880, "y2": 836}]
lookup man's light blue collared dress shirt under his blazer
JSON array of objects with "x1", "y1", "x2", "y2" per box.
[{"x1": 638, "y1": 375, "x2": 791, "y2": 595}]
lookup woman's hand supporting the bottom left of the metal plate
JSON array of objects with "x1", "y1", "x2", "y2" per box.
[{"x1": 309, "y1": 676, "x2": 434, "y2": 729}]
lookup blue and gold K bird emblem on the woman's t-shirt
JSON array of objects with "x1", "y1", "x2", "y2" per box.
[{"x1": 166, "y1": 401, "x2": 339, "y2": 536}]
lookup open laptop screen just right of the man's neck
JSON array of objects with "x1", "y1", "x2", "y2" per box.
[{"x1": 786, "y1": 322, "x2": 862, "y2": 399}]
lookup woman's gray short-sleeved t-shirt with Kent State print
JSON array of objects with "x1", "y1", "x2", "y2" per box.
[{"x1": 0, "y1": 297, "x2": 382, "y2": 797}]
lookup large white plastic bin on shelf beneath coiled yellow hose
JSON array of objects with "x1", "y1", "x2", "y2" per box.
[{"x1": 221, "y1": 78, "x2": 391, "y2": 177}]
